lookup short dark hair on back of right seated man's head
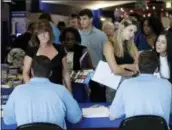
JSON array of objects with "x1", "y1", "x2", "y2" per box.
[{"x1": 139, "y1": 51, "x2": 159, "y2": 74}]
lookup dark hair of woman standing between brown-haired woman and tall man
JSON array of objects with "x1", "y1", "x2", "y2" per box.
[{"x1": 60, "y1": 27, "x2": 81, "y2": 43}]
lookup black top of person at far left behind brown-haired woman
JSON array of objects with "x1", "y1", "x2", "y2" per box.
[{"x1": 12, "y1": 32, "x2": 32, "y2": 52}]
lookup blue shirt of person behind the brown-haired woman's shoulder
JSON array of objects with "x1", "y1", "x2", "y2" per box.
[{"x1": 50, "y1": 23, "x2": 60, "y2": 44}]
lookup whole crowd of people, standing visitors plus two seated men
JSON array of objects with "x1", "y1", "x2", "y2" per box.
[{"x1": 3, "y1": 9, "x2": 172, "y2": 129}]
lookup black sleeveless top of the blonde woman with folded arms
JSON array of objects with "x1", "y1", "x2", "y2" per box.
[{"x1": 115, "y1": 44, "x2": 134, "y2": 65}]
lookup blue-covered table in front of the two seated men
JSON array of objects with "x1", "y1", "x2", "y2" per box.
[{"x1": 1, "y1": 103, "x2": 172, "y2": 130}]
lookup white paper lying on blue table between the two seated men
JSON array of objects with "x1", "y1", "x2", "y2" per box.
[{"x1": 82, "y1": 106, "x2": 109, "y2": 118}]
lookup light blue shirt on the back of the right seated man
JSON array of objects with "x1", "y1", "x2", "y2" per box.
[{"x1": 111, "y1": 74, "x2": 172, "y2": 123}]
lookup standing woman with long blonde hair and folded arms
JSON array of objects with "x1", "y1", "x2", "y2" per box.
[{"x1": 104, "y1": 17, "x2": 139, "y2": 101}]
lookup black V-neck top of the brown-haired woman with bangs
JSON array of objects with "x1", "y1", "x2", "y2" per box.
[{"x1": 26, "y1": 44, "x2": 66, "y2": 84}]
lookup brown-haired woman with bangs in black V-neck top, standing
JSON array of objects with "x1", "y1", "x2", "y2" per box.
[{"x1": 23, "y1": 20, "x2": 72, "y2": 91}]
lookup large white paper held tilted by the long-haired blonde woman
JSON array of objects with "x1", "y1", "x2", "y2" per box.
[{"x1": 92, "y1": 61, "x2": 122, "y2": 90}]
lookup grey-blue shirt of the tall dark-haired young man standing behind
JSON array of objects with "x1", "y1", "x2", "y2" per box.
[{"x1": 80, "y1": 27, "x2": 108, "y2": 67}]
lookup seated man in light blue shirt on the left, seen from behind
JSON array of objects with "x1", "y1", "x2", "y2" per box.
[{"x1": 3, "y1": 56, "x2": 82, "y2": 129}]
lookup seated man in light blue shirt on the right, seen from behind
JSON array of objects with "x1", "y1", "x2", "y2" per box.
[{"x1": 109, "y1": 51, "x2": 172, "y2": 123}]
